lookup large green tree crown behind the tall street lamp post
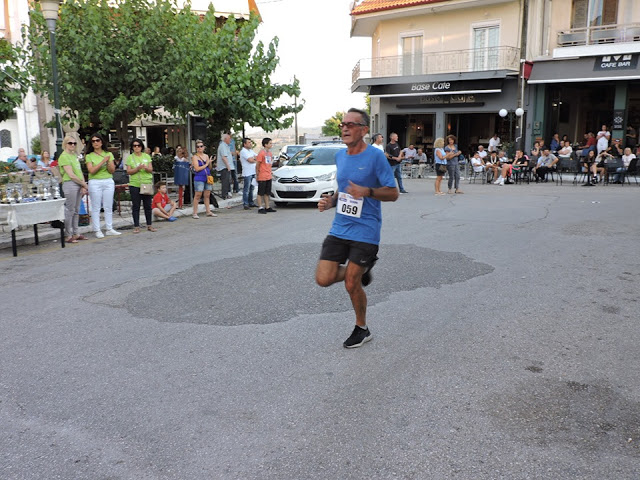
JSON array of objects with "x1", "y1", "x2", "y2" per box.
[{"x1": 29, "y1": 0, "x2": 177, "y2": 149}]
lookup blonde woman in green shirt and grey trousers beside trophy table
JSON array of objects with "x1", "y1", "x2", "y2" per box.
[{"x1": 58, "y1": 135, "x2": 88, "y2": 243}]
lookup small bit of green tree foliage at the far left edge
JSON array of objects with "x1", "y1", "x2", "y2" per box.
[{"x1": 0, "y1": 38, "x2": 29, "y2": 122}]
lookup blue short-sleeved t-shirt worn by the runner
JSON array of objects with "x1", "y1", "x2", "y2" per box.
[{"x1": 329, "y1": 145, "x2": 396, "y2": 245}]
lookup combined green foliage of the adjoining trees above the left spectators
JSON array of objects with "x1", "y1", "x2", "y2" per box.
[{"x1": 25, "y1": 0, "x2": 302, "y2": 151}]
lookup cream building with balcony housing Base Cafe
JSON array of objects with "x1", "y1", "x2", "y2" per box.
[{"x1": 351, "y1": 0, "x2": 529, "y2": 155}]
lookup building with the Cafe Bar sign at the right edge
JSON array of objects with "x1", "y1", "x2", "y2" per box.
[{"x1": 529, "y1": 0, "x2": 640, "y2": 146}]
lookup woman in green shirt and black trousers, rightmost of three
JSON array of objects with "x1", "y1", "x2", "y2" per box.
[{"x1": 125, "y1": 138, "x2": 156, "y2": 233}]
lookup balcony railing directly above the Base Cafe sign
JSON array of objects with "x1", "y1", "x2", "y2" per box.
[{"x1": 351, "y1": 47, "x2": 520, "y2": 83}]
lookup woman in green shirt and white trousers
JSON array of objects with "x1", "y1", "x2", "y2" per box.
[{"x1": 86, "y1": 133, "x2": 120, "y2": 238}]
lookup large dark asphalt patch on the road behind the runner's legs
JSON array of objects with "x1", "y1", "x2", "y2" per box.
[{"x1": 124, "y1": 243, "x2": 494, "y2": 326}]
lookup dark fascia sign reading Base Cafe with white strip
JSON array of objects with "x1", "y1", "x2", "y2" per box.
[{"x1": 369, "y1": 79, "x2": 502, "y2": 97}]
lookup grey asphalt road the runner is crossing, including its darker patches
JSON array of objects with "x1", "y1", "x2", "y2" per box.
[{"x1": 0, "y1": 180, "x2": 640, "y2": 480}]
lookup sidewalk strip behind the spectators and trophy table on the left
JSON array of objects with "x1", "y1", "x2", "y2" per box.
[{"x1": 0, "y1": 192, "x2": 242, "y2": 251}]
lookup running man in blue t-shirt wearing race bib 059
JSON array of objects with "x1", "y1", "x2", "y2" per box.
[{"x1": 316, "y1": 108, "x2": 399, "y2": 348}]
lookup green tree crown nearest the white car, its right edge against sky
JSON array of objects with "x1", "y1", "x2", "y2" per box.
[{"x1": 158, "y1": 6, "x2": 302, "y2": 148}]
